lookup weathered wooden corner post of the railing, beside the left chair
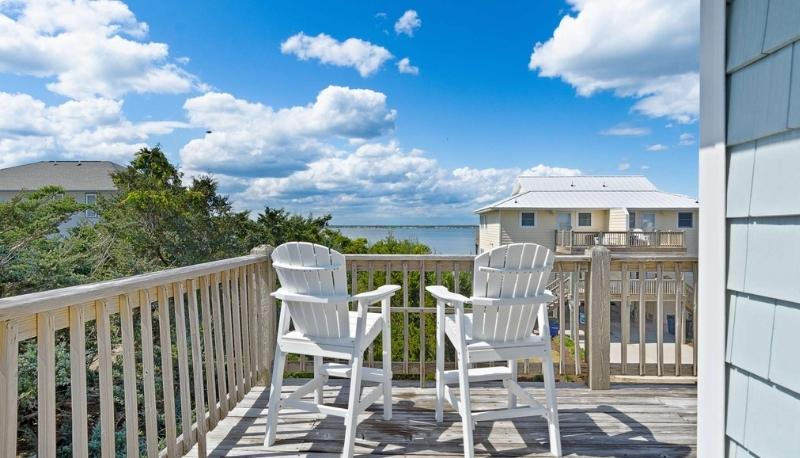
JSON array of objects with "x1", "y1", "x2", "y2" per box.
[{"x1": 250, "y1": 245, "x2": 278, "y2": 383}]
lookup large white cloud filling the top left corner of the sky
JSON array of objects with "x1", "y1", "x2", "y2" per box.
[{"x1": 0, "y1": 0, "x2": 206, "y2": 99}]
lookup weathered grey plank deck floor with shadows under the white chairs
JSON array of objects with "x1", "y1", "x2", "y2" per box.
[{"x1": 188, "y1": 380, "x2": 697, "y2": 457}]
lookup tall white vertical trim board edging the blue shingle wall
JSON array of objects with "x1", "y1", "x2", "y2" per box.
[{"x1": 695, "y1": 0, "x2": 732, "y2": 458}]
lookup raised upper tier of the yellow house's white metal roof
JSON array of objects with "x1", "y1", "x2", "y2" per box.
[{"x1": 511, "y1": 175, "x2": 658, "y2": 195}]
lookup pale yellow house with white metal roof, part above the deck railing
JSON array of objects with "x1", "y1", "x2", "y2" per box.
[{"x1": 475, "y1": 176, "x2": 698, "y2": 254}]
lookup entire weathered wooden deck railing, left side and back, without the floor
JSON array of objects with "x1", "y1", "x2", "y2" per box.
[{"x1": 0, "y1": 247, "x2": 697, "y2": 457}]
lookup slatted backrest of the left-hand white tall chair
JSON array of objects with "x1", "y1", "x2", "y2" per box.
[{"x1": 272, "y1": 242, "x2": 350, "y2": 338}]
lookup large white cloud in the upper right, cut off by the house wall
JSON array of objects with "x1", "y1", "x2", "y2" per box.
[{"x1": 529, "y1": 0, "x2": 700, "y2": 123}]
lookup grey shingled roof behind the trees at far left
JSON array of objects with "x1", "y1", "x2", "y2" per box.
[{"x1": 0, "y1": 161, "x2": 124, "y2": 191}]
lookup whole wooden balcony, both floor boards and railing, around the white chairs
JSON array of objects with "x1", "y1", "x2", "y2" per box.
[{"x1": 0, "y1": 247, "x2": 697, "y2": 457}]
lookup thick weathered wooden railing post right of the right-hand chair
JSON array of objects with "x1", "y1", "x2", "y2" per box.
[{"x1": 585, "y1": 246, "x2": 611, "y2": 390}]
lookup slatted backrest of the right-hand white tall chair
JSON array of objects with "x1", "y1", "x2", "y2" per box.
[{"x1": 472, "y1": 243, "x2": 555, "y2": 342}]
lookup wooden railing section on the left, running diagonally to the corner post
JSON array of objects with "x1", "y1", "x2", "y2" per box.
[{"x1": 0, "y1": 250, "x2": 275, "y2": 457}]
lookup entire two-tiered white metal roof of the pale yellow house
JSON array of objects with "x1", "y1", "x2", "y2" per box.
[{"x1": 475, "y1": 176, "x2": 699, "y2": 213}]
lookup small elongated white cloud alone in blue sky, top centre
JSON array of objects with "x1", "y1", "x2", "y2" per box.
[{"x1": 281, "y1": 32, "x2": 393, "y2": 77}]
